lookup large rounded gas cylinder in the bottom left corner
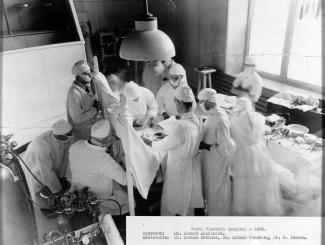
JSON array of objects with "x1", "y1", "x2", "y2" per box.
[{"x1": 0, "y1": 164, "x2": 35, "y2": 245}]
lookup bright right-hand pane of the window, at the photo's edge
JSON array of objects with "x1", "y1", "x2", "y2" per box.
[{"x1": 288, "y1": 0, "x2": 322, "y2": 86}]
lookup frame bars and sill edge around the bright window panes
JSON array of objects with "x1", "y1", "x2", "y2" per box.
[{"x1": 245, "y1": 0, "x2": 325, "y2": 95}]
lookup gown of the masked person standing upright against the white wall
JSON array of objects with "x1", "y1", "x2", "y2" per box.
[{"x1": 66, "y1": 83, "x2": 97, "y2": 140}]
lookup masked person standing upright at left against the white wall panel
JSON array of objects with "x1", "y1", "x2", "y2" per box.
[{"x1": 66, "y1": 60, "x2": 101, "y2": 140}]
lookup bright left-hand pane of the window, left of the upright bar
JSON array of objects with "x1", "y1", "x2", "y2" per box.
[{"x1": 249, "y1": 0, "x2": 290, "y2": 75}]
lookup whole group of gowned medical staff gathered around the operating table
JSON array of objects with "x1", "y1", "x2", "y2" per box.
[{"x1": 24, "y1": 59, "x2": 282, "y2": 216}]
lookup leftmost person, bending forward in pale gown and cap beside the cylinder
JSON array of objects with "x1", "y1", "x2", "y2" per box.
[{"x1": 23, "y1": 119, "x2": 72, "y2": 208}]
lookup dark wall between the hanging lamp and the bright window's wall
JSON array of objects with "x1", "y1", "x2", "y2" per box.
[{"x1": 149, "y1": 0, "x2": 227, "y2": 86}]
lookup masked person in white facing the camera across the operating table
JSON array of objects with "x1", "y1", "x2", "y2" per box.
[{"x1": 156, "y1": 62, "x2": 196, "y2": 119}]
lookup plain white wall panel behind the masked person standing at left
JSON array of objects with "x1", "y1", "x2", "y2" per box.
[{"x1": 0, "y1": 41, "x2": 85, "y2": 145}]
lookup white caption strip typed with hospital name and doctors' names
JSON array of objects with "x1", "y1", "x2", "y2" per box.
[{"x1": 126, "y1": 216, "x2": 321, "y2": 245}]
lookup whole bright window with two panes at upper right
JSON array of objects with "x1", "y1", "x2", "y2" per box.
[{"x1": 246, "y1": 0, "x2": 322, "y2": 91}]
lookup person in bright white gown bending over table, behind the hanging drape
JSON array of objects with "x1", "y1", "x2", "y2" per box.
[{"x1": 123, "y1": 81, "x2": 158, "y2": 127}]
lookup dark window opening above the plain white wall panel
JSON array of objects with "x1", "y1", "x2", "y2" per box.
[{"x1": 0, "y1": 0, "x2": 80, "y2": 52}]
